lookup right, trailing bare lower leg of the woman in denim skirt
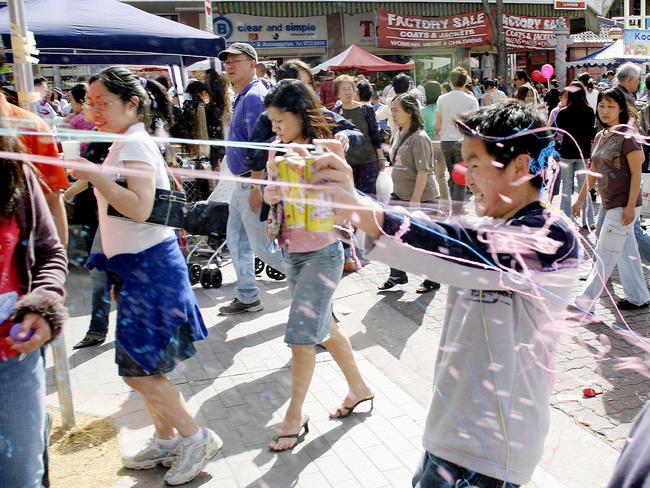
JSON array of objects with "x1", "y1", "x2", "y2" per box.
[{"x1": 323, "y1": 318, "x2": 373, "y2": 417}]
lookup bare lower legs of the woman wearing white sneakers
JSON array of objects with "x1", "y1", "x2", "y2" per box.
[{"x1": 124, "y1": 375, "x2": 199, "y2": 439}]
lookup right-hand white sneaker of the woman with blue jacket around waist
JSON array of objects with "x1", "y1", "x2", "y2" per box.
[{"x1": 163, "y1": 427, "x2": 223, "y2": 485}]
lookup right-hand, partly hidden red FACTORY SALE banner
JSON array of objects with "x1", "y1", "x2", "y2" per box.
[{"x1": 503, "y1": 14, "x2": 566, "y2": 49}]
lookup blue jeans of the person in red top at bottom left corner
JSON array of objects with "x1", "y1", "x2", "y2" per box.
[{"x1": 0, "y1": 350, "x2": 45, "y2": 488}]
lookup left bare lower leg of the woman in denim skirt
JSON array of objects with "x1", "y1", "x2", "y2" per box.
[{"x1": 269, "y1": 346, "x2": 316, "y2": 451}]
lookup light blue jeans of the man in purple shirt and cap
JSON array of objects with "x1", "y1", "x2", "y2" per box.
[{"x1": 226, "y1": 183, "x2": 286, "y2": 303}]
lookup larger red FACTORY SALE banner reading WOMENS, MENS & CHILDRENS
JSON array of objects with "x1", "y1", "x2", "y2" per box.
[{"x1": 377, "y1": 10, "x2": 492, "y2": 49}]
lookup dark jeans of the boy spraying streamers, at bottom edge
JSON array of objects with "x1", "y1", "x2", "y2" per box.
[{"x1": 413, "y1": 452, "x2": 519, "y2": 488}]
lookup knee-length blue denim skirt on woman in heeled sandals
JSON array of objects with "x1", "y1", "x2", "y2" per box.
[{"x1": 284, "y1": 241, "x2": 343, "y2": 346}]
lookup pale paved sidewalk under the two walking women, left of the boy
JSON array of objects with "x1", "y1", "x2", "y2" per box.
[{"x1": 48, "y1": 268, "x2": 426, "y2": 488}]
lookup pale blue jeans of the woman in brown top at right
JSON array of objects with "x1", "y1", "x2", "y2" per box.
[{"x1": 576, "y1": 207, "x2": 650, "y2": 312}]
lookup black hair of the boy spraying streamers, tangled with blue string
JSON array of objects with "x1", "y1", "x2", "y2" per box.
[{"x1": 456, "y1": 100, "x2": 553, "y2": 190}]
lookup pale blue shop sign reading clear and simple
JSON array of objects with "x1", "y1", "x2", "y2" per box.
[{"x1": 213, "y1": 14, "x2": 327, "y2": 49}]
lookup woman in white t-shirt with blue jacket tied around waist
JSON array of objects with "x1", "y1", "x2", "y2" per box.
[{"x1": 75, "y1": 67, "x2": 223, "y2": 485}]
